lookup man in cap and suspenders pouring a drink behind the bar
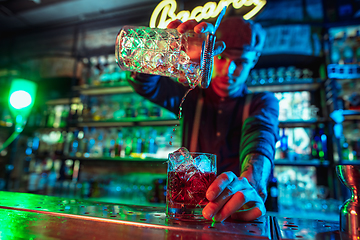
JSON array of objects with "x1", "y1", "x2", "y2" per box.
[{"x1": 130, "y1": 17, "x2": 279, "y2": 222}]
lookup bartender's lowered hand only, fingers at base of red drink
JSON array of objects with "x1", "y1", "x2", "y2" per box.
[{"x1": 202, "y1": 172, "x2": 266, "y2": 222}]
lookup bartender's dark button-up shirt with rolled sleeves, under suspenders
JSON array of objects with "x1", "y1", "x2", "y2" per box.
[{"x1": 130, "y1": 74, "x2": 279, "y2": 175}]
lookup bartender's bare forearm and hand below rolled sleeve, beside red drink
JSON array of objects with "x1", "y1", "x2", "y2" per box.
[{"x1": 202, "y1": 156, "x2": 271, "y2": 222}]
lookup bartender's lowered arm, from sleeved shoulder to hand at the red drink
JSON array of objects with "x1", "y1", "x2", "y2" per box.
[{"x1": 203, "y1": 92, "x2": 279, "y2": 221}]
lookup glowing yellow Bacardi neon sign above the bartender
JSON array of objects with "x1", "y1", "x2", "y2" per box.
[{"x1": 150, "y1": 0, "x2": 266, "y2": 28}]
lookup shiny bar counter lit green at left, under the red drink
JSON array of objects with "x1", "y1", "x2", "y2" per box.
[{"x1": 0, "y1": 191, "x2": 340, "y2": 240}]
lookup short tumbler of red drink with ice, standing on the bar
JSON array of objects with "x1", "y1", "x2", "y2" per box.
[{"x1": 166, "y1": 148, "x2": 216, "y2": 221}]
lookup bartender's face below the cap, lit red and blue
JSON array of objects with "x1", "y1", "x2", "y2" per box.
[{"x1": 210, "y1": 49, "x2": 258, "y2": 97}]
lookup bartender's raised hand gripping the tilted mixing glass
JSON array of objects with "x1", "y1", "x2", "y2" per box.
[{"x1": 167, "y1": 19, "x2": 226, "y2": 84}]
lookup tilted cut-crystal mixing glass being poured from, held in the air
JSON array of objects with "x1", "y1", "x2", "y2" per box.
[{"x1": 115, "y1": 26, "x2": 211, "y2": 88}]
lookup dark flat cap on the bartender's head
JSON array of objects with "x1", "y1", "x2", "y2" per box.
[{"x1": 216, "y1": 16, "x2": 266, "y2": 53}]
